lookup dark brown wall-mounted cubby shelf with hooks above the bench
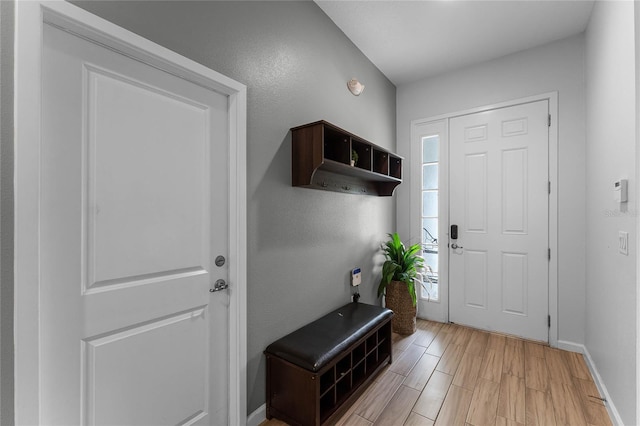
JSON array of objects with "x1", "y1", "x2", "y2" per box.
[{"x1": 291, "y1": 121, "x2": 403, "y2": 196}]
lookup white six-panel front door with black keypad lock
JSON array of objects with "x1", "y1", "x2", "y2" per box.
[{"x1": 449, "y1": 100, "x2": 549, "y2": 341}]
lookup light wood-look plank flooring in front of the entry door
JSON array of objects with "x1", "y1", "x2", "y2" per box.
[{"x1": 261, "y1": 320, "x2": 612, "y2": 426}]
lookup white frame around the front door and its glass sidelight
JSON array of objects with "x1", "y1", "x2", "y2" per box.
[{"x1": 410, "y1": 91, "x2": 558, "y2": 347}]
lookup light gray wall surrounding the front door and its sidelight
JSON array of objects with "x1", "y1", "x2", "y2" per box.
[{"x1": 396, "y1": 35, "x2": 586, "y2": 344}]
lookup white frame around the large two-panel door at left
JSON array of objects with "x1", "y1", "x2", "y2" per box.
[{"x1": 14, "y1": 0, "x2": 247, "y2": 425}]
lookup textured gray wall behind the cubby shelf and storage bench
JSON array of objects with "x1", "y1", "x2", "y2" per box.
[{"x1": 67, "y1": 1, "x2": 396, "y2": 413}]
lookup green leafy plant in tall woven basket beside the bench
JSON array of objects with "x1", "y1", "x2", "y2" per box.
[{"x1": 378, "y1": 233, "x2": 424, "y2": 335}]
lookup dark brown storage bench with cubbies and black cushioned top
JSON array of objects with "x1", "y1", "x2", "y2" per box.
[{"x1": 264, "y1": 303, "x2": 393, "y2": 426}]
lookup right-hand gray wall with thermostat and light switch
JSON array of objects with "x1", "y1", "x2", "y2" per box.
[{"x1": 585, "y1": 2, "x2": 638, "y2": 425}]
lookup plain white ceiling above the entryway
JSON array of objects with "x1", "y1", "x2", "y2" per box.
[{"x1": 315, "y1": 0, "x2": 593, "y2": 85}]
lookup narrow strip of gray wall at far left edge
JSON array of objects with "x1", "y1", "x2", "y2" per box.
[{"x1": 0, "y1": 1, "x2": 14, "y2": 425}]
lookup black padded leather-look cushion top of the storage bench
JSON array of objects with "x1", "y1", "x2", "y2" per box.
[{"x1": 265, "y1": 303, "x2": 393, "y2": 372}]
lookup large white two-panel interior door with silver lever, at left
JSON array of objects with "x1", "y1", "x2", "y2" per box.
[{"x1": 39, "y1": 21, "x2": 229, "y2": 425}]
